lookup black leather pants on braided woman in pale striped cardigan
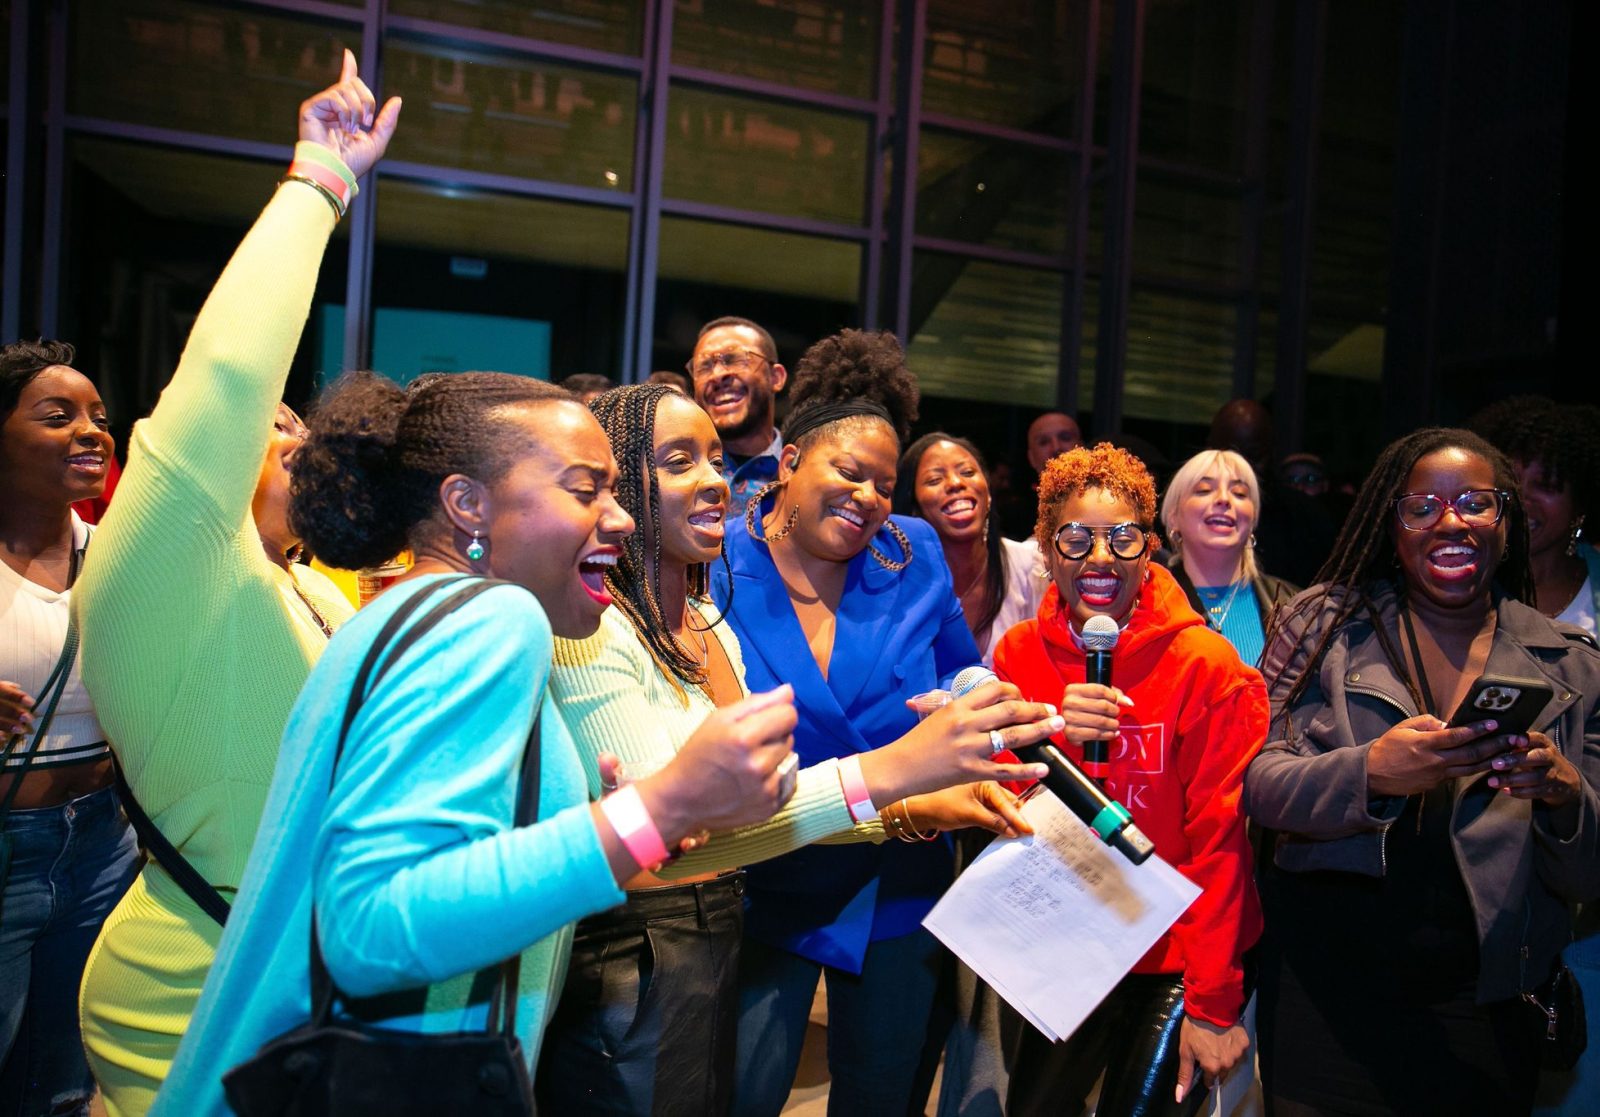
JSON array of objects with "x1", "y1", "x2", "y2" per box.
[{"x1": 536, "y1": 872, "x2": 744, "y2": 1117}]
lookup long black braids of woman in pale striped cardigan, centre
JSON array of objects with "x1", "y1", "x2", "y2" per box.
[{"x1": 589, "y1": 384, "x2": 733, "y2": 688}]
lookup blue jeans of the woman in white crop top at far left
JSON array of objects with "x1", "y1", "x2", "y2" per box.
[{"x1": 0, "y1": 787, "x2": 139, "y2": 1117}]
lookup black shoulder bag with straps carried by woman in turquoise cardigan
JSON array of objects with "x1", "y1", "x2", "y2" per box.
[{"x1": 222, "y1": 578, "x2": 539, "y2": 1117}]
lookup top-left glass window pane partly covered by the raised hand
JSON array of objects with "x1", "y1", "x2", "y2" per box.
[{"x1": 67, "y1": 0, "x2": 362, "y2": 149}]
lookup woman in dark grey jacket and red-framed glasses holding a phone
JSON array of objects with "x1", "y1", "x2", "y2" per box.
[{"x1": 1245, "y1": 429, "x2": 1600, "y2": 1115}]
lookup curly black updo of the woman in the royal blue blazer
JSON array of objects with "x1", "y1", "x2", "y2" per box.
[{"x1": 789, "y1": 330, "x2": 922, "y2": 450}]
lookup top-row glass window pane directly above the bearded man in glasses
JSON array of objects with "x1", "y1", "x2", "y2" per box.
[{"x1": 672, "y1": 0, "x2": 883, "y2": 98}]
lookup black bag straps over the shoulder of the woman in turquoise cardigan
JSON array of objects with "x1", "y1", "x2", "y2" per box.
[{"x1": 310, "y1": 578, "x2": 541, "y2": 1037}]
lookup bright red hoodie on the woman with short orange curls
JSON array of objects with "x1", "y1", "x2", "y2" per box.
[{"x1": 995, "y1": 565, "x2": 1267, "y2": 1027}]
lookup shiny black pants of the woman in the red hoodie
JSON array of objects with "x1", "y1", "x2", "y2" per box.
[{"x1": 1000, "y1": 973, "x2": 1206, "y2": 1117}]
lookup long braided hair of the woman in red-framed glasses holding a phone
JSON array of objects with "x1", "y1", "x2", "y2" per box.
[{"x1": 1266, "y1": 427, "x2": 1533, "y2": 709}]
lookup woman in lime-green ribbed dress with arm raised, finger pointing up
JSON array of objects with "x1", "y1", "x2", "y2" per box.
[{"x1": 74, "y1": 51, "x2": 400, "y2": 1117}]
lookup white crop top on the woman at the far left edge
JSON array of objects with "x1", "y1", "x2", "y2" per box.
[{"x1": 0, "y1": 512, "x2": 107, "y2": 768}]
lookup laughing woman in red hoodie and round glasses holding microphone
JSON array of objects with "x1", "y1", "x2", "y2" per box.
[{"x1": 966, "y1": 443, "x2": 1267, "y2": 1114}]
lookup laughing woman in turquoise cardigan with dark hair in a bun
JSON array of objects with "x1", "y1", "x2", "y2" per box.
[{"x1": 158, "y1": 373, "x2": 795, "y2": 1117}]
